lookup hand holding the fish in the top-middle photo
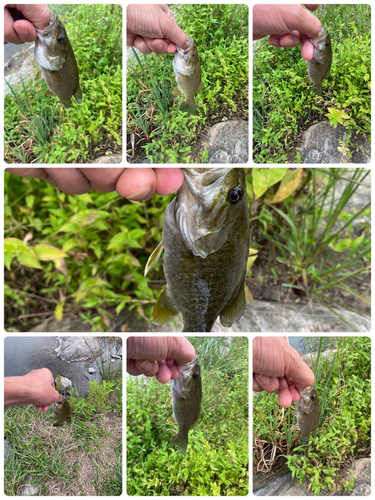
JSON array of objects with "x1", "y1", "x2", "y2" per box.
[{"x1": 126, "y1": 4, "x2": 187, "y2": 54}]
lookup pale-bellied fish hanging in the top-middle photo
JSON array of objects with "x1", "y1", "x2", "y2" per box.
[{"x1": 172, "y1": 36, "x2": 204, "y2": 115}]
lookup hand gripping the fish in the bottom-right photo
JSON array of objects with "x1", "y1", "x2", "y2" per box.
[{"x1": 253, "y1": 337, "x2": 314, "y2": 408}]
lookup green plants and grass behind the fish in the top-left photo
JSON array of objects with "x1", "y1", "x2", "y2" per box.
[{"x1": 4, "y1": 4, "x2": 122, "y2": 163}]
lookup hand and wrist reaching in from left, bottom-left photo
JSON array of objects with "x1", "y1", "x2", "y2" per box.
[{"x1": 4, "y1": 368, "x2": 59, "y2": 411}]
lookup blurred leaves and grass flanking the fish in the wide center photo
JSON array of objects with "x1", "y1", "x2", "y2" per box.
[{"x1": 4, "y1": 168, "x2": 371, "y2": 331}]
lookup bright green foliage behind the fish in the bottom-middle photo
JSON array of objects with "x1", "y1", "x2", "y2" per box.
[{"x1": 126, "y1": 337, "x2": 249, "y2": 496}]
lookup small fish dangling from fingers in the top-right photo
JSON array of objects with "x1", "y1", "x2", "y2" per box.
[{"x1": 307, "y1": 26, "x2": 332, "y2": 96}]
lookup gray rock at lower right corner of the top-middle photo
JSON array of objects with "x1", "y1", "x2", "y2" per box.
[{"x1": 201, "y1": 121, "x2": 249, "y2": 163}]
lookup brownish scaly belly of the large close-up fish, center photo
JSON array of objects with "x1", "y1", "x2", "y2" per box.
[{"x1": 163, "y1": 202, "x2": 248, "y2": 332}]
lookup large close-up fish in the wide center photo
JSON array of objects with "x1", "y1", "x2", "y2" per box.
[{"x1": 145, "y1": 168, "x2": 250, "y2": 332}]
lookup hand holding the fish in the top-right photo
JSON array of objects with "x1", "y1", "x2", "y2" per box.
[{"x1": 253, "y1": 4, "x2": 321, "y2": 61}]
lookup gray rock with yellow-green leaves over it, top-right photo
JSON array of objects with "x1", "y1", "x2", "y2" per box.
[{"x1": 301, "y1": 121, "x2": 371, "y2": 163}]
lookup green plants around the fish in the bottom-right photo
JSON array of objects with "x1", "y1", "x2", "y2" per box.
[{"x1": 253, "y1": 337, "x2": 371, "y2": 495}]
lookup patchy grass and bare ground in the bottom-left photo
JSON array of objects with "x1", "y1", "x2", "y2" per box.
[{"x1": 4, "y1": 378, "x2": 122, "y2": 496}]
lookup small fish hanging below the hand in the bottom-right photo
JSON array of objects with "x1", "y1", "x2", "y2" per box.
[{"x1": 297, "y1": 385, "x2": 320, "y2": 442}]
